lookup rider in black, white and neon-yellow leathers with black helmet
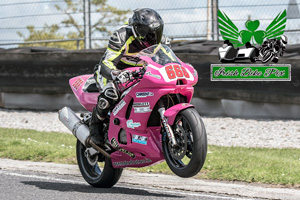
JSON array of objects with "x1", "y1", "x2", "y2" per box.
[{"x1": 89, "y1": 8, "x2": 170, "y2": 146}]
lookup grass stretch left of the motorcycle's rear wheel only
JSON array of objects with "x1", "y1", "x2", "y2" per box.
[{"x1": 0, "y1": 128, "x2": 77, "y2": 164}]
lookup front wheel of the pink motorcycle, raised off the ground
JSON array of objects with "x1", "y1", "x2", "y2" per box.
[{"x1": 162, "y1": 108, "x2": 207, "y2": 177}]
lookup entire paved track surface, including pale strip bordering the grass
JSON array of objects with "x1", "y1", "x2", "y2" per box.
[{"x1": 0, "y1": 159, "x2": 300, "y2": 200}]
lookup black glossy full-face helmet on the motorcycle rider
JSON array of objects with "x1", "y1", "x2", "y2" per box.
[{"x1": 129, "y1": 8, "x2": 164, "y2": 48}]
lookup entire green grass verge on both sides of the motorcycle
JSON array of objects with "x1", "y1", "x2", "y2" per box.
[{"x1": 0, "y1": 128, "x2": 300, "y2": 186}]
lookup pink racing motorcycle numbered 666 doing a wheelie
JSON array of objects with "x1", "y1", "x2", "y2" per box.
[{"x1": 59, "y1": 44, "x2": 207, "y2": 187}]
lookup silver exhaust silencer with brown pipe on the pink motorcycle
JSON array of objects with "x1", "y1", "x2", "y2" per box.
[{"x1": 58, "y1": 107, "x2": 110, "y2": 158}]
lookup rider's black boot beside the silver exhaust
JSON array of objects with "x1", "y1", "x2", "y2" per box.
[{"x1": 89, "y1": 107, "x2": 104, "y2": 146}]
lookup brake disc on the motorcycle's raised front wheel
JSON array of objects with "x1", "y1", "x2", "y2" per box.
[{"x1": 168, "y1": 125, "x2": 187, "y2": 160}]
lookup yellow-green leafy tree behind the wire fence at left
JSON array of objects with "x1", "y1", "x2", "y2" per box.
[{"x1": 18, "y1": 0, "x2": 129, "y2": 49}]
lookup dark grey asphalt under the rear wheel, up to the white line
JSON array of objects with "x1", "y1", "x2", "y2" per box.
[{"x1": 0, "y1": 171, "x2": 253, "y2": 200}]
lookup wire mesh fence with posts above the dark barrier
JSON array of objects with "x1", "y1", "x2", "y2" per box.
[{"x1": 0, "y1": 0, "x2": 300, "y2": 49}]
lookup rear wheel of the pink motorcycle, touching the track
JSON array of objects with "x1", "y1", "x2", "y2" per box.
[{"x1": 76, "y1": 140, "x2": 123, "y2": 188}]
